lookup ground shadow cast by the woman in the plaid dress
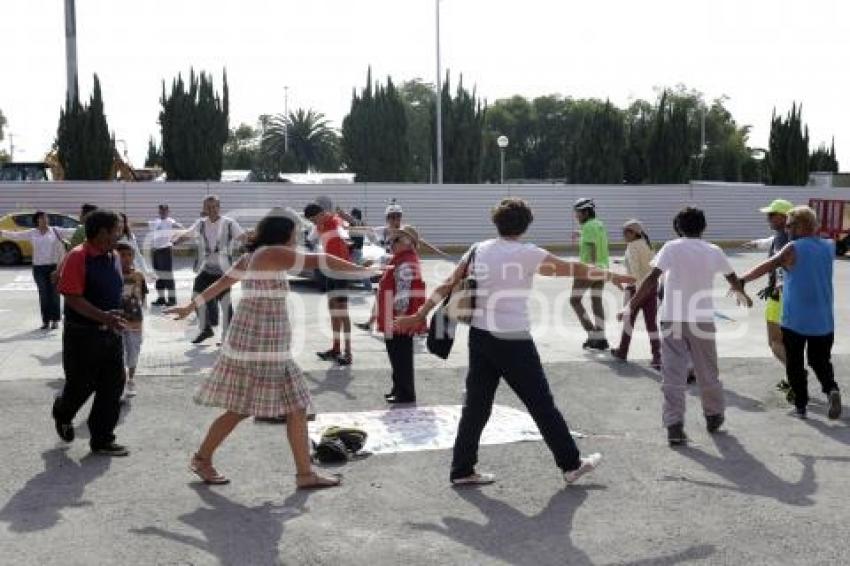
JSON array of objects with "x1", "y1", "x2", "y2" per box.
[{"x1": 130, "y1": 483, "x2": 309, "y2": 566}]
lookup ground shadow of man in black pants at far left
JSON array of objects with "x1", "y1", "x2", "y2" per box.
[{"x1": 0, "y1": 447, "x2": 111, "y2": 533}]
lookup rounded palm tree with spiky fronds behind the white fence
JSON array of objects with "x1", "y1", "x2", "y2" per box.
[{"x1": 263, "y1": 108, "x2": 339, "y2": 173}]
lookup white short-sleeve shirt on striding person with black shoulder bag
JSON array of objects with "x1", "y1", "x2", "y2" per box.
[{"x1": 464, "y1": 238, "x2": 549, "y2": 333}]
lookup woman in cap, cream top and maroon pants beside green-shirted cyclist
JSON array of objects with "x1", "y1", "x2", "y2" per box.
[{"x1": 611, "y1": 220, "x2": 661, "y2": 370}]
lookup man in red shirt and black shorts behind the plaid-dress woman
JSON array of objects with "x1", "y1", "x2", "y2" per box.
[{"x1": 304, "y1": 203, "x2": 352, "y2": 366}]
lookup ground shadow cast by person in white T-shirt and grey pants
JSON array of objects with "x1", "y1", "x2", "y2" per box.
[{"x1": 667, "y1": 433, "x2": 817, "y2": 507}]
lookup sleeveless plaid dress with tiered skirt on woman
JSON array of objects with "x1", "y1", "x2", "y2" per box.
[{"x1": 195, "y1": 271, "x2": 311, "y2": 417}]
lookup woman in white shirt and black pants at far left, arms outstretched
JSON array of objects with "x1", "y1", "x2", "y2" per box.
[{"x1": 0, "y1": 210, "x2": 76, "y2": 330}]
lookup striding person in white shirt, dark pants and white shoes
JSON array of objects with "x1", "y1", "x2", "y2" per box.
[{"x1": 397, "y1": 198, "x2": 634, "y2": 485}]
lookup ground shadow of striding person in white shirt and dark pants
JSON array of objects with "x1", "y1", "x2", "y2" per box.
[{"x1": 408, "y1": 485, "x2": 715, "y2": 566}]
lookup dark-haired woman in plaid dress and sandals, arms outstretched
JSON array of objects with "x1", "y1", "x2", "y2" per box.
[{"x1": 165, "y1": 209, "x2": 372, "y2": 489}]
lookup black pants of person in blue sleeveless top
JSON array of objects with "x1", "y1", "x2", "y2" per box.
[{"x1": 782, "y1": 327, "x2": 838, "y2": 407}]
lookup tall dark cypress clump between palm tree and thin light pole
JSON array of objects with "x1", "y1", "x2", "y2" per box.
[{"x1": 342, "y1": 68, "x2": 411, "y2": 182}]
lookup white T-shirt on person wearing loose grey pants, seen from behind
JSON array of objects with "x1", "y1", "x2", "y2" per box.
[{"x1": 651, "y1": 238, "x2": 735, "y2": 322}]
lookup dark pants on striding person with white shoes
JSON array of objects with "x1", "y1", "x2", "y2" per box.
[{"x1": 451, "y1": 328, "x2": 581, "y2": 479}]
